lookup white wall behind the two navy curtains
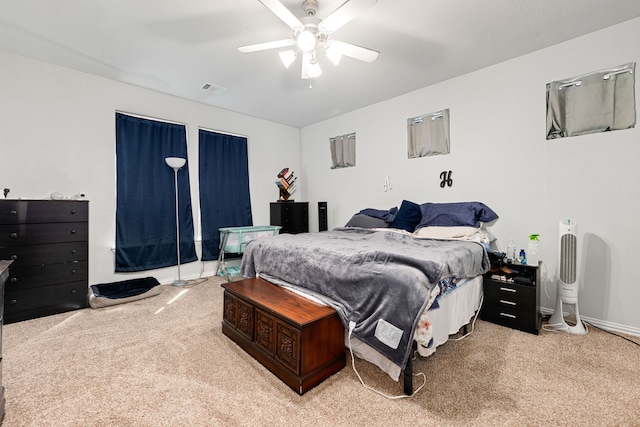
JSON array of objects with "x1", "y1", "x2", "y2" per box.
[{"x1": 0, "y1": 52, "x2": 303, "y2": 284}]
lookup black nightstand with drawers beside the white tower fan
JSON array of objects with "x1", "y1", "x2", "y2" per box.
[{"x1": 481, "y1": 261, "x2": 542, "y2": 335}]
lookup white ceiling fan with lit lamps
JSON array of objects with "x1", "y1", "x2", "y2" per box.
[{"x1": 238, "y1": 0, "x2": 380, "y2": 79}]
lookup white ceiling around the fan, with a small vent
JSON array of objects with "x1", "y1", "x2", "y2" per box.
[{"x1": 0, "y1": 0, "x2": 640, "y2": 127}]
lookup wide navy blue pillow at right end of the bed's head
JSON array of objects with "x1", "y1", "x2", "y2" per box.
[{"x1": 417, "y1": 202, "x2": 498, "y2": 228}]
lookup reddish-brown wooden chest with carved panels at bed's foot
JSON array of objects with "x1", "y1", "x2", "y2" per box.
[{"x1": 222, "y1": 278, "x2": 346, "y2": 395}]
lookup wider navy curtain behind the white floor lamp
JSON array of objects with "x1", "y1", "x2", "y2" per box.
[{"x1": 115, "y1": 113, "x2": 198, "y2": 272}]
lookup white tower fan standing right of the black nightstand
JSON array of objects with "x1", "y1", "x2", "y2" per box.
[{"x1": 549, "y1": 219, "x2": 587, "y2": 335}]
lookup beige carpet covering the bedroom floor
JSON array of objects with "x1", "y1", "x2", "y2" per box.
[{"x1": 2, "y1": 278, "x2": 640, "y2": 427}]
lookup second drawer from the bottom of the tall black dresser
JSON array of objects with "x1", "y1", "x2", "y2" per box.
[{"x1": 6, "y1": 261, "x2": 89, "y2": 292}]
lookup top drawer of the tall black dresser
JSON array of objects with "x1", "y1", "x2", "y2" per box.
[{"x1": 0, "y1": 200, "x2": 89, "y2": 224}]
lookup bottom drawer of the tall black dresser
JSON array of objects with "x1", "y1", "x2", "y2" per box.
[{"x1": 4, "y1": 281, "x2": 88, "y2": 323}]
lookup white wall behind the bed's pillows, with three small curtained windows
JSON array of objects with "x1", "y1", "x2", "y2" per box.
[{"x1": 302, "y1": 19, "x2": 640, "y2": 335}]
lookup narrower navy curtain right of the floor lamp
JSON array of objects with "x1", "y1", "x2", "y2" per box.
[{"x1": 198, "y1": 129, "x2": 253, "y2": 261}]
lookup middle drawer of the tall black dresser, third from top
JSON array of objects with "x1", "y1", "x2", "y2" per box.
[{"x1": 0, "y1": 241, "x2": 89, "y2": 268}]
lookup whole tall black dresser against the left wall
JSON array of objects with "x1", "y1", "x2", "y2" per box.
[{"x1": 0, "y1": 200, "x2": 89, "y2": 323}]
